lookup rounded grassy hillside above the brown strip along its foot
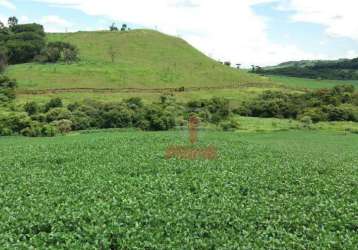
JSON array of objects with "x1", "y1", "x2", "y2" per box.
[{"x1": 6, "y1": 30, "x2": 268, "y2": 90}]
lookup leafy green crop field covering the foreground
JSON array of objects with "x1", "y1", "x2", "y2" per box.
[{"x1": 0, "y1": 131, "x2": 358, "y2": 249}]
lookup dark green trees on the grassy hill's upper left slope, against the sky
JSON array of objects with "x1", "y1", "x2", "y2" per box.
[{"x1": 0, "y1": 17, "x2": 78, "y2": 67}]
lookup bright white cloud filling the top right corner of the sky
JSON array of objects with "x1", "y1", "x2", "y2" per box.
[{"x1": 279, "y1": 0, "x2": 358, "y2": 40}]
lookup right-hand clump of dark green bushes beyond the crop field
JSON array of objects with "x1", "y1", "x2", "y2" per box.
[{"x1": 234, "y1": 85, "x2": 358, "y2": 122}]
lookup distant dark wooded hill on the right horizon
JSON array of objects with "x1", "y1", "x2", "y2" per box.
[{"x1": 255, "y1": 58, "x2": 358, "y2": 80}]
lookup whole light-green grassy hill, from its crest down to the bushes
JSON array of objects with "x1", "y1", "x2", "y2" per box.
[{"x1": 6, "y1": 30, "x2": 352, "y2": 102}]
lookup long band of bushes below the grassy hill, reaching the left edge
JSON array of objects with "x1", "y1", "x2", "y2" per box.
[{"x1": 0, "y1": 95, "x2": 236, "y2": 136}]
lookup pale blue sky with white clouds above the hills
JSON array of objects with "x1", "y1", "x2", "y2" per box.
[{"x1": 0, "y1": 0, "x2": 358, "y2": 67}]
